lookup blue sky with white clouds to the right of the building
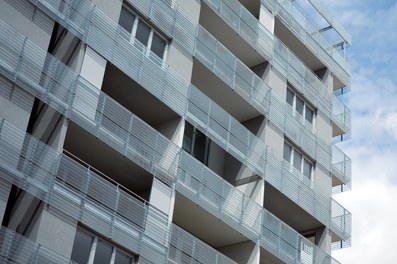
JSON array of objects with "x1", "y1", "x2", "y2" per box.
[{"x1": 322, "y1": 0, "x2": 397, "y2": 264}]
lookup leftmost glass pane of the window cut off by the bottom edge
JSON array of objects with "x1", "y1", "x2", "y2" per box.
[{"x1": 72, "y1": 229, "x2": 93, "y2": 264}]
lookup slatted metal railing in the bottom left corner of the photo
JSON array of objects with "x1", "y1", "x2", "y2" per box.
[{"x1": 0, "y1": 226, "x2": 75, "y2": 264}]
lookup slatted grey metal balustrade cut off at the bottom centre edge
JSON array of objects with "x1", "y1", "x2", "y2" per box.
[{"x1": 168, "y1": 224, "x2": 236, "y2": 264}]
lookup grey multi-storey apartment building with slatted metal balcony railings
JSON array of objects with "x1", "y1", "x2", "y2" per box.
[{"x1": 0, "y1": 0, "x2": 351, "y2": 264}]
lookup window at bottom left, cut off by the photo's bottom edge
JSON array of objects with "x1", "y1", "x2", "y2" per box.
[{"x1": 72, "y1": 228, "x2": 136, "y2": 264}]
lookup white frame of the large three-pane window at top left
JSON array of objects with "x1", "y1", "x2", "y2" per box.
[{"x1": 118, "y1": 4, "x2": 169, "y2": 63}]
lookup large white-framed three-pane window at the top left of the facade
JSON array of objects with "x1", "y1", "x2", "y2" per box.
[{"x1": 119, "y1": 6, "x2": 168, "y2": 60}]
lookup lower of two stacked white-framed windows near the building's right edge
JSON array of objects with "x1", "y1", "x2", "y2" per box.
[{"x1": 283, "y1": 142, "x2": 313, "y2": 179}]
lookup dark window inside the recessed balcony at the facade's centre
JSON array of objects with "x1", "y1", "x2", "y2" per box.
[{"x1": 182, "y1": 123, "x2": 210, "y2": 165}]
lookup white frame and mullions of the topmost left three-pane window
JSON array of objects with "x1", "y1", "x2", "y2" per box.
[{"x1": 120, "y1": 4, "x2": 169, "y2": 66}]
